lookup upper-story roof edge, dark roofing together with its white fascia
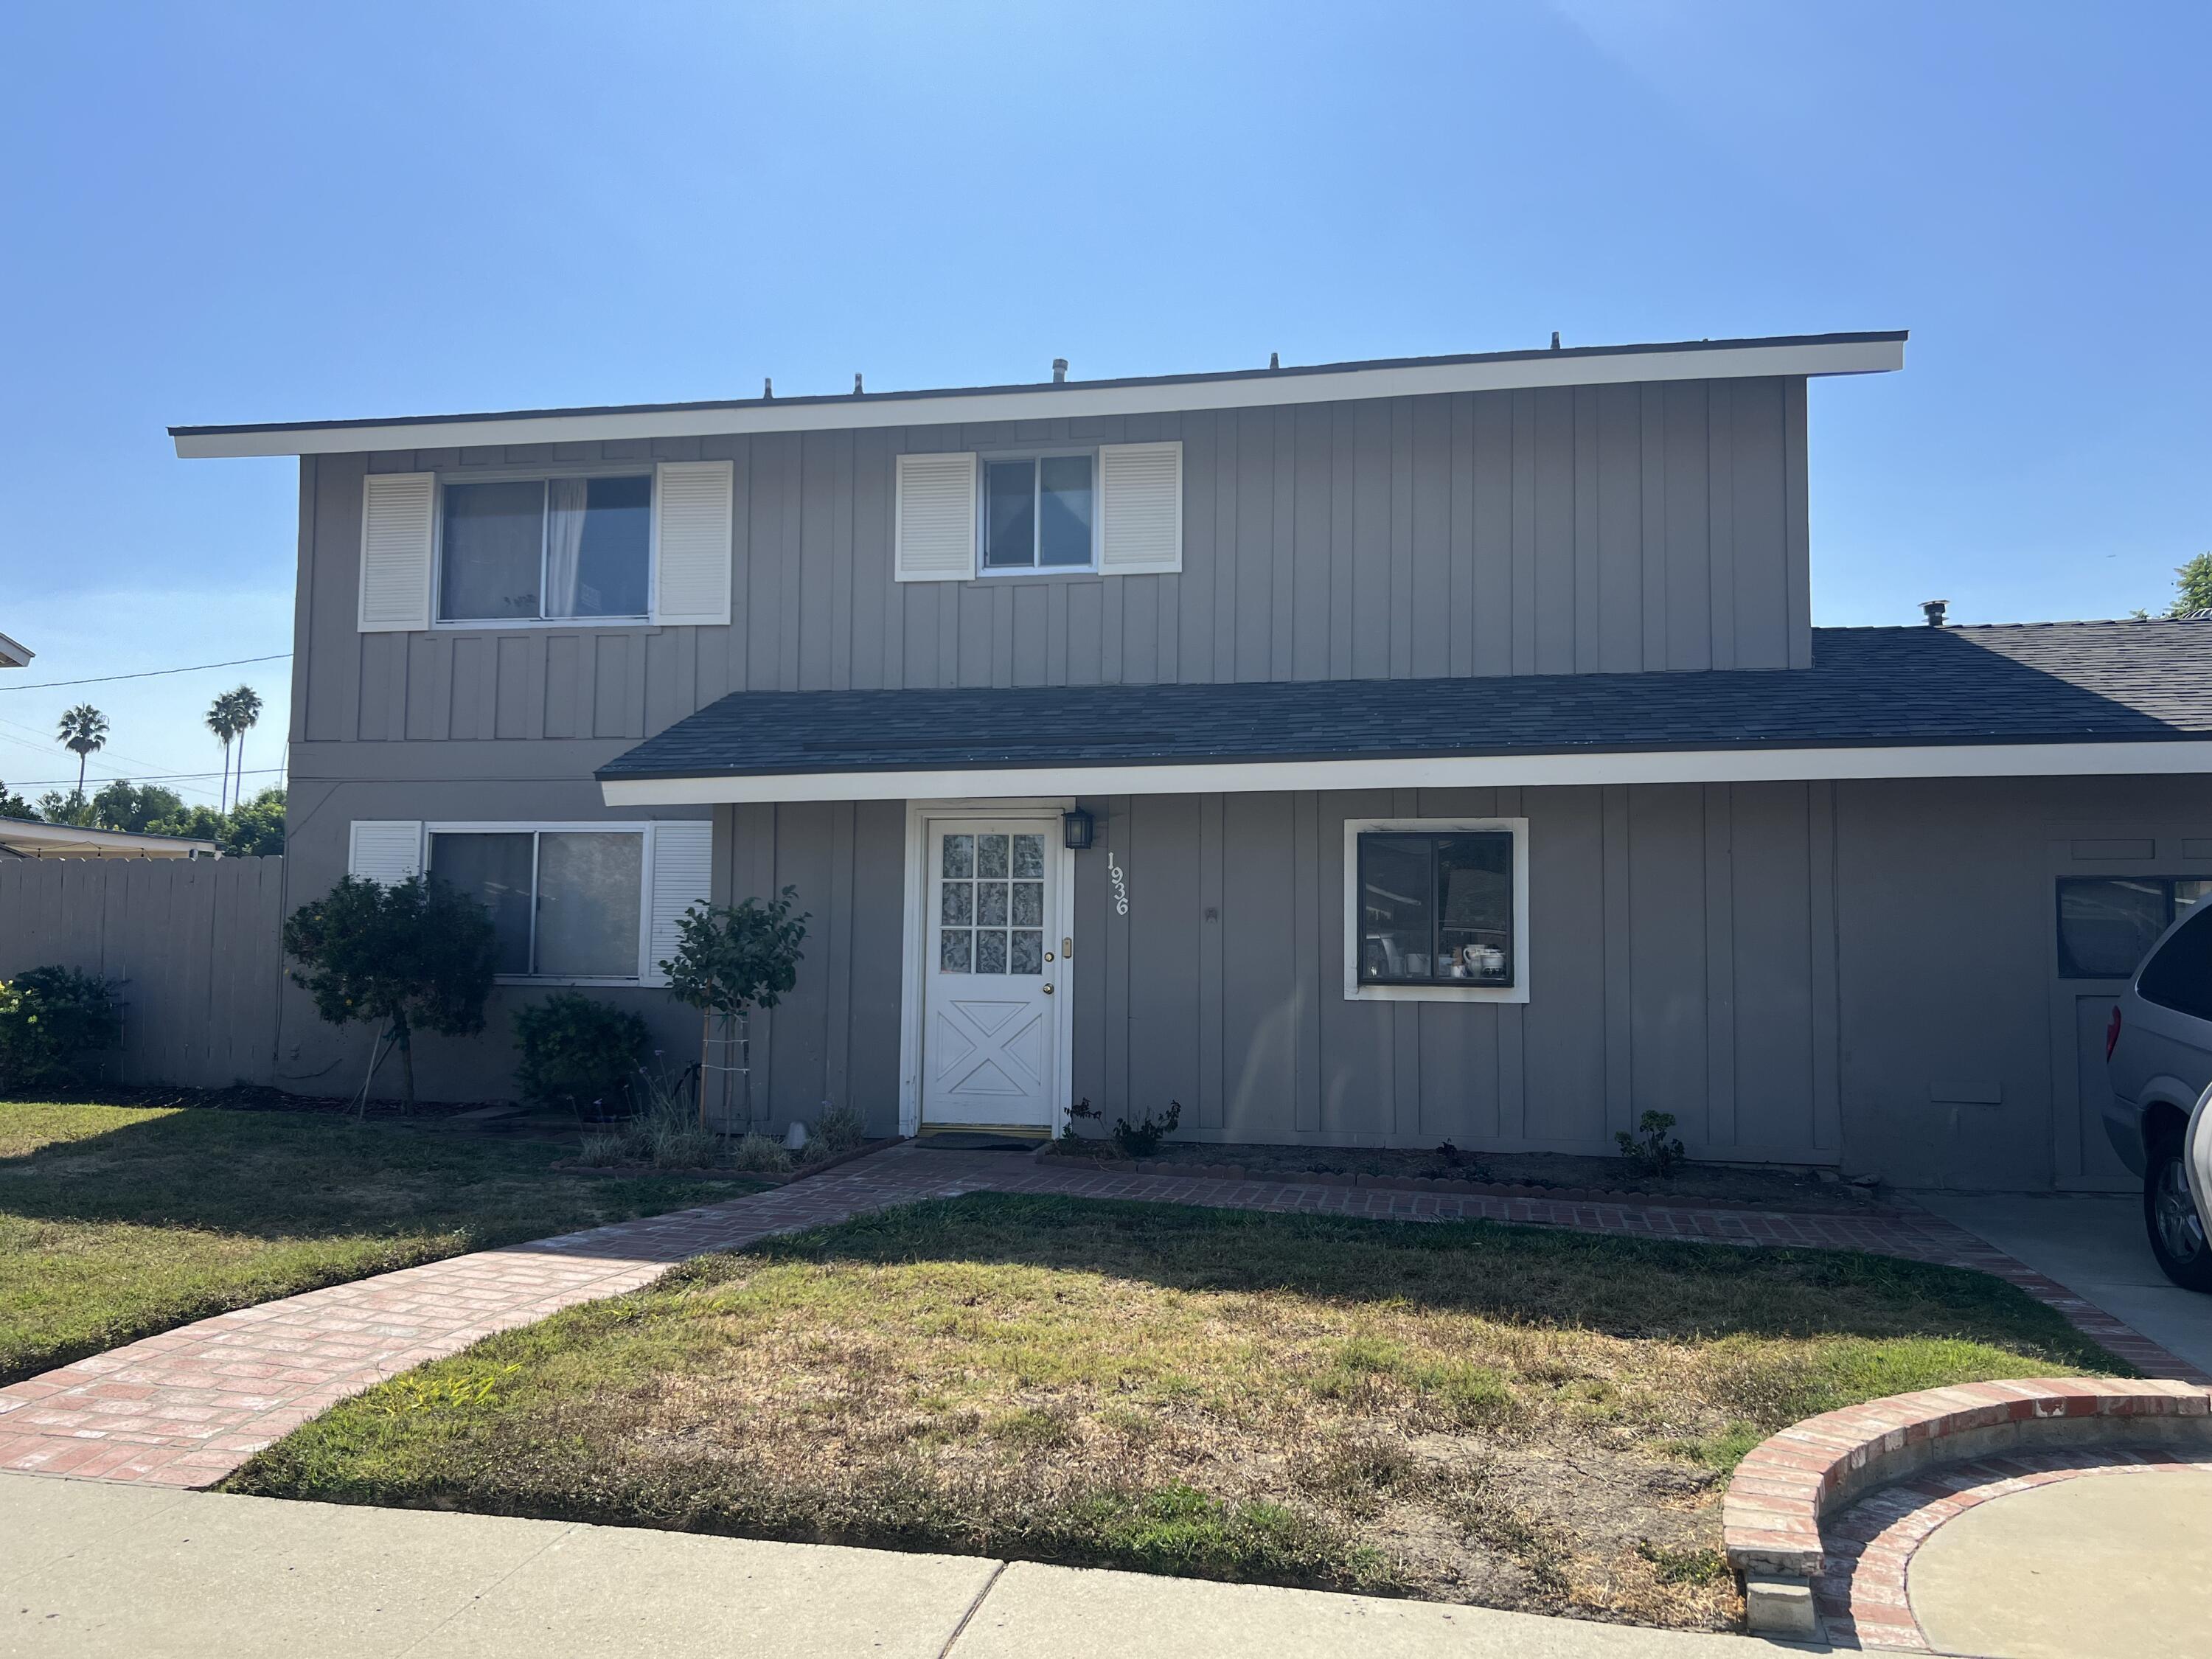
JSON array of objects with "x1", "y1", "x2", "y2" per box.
[{"x1": 168, "y1": 330, "x2": 1905, "y2": 458}]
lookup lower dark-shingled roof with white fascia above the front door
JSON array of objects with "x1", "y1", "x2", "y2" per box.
[{"x1": 597, "y1": 622, "x2": 2212, "y2": 807}]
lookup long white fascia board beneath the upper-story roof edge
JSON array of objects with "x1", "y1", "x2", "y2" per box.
[{"x1": 177, "y1": 341, "x2": 1905, "y2": 460}]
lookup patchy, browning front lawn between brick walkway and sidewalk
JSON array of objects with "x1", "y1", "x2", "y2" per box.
[{"x1": 230, "y1": 1194, "x2": 2124, "y2": 1626}]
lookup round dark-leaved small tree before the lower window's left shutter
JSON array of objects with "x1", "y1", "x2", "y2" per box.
[{"x1": 283, "y1": 876, "x2": 498, "y2": 1106}]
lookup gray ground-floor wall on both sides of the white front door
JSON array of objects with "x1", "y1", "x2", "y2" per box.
[{"x1": 717, "y1": 779, "x2": 2212, "y2": 1190}]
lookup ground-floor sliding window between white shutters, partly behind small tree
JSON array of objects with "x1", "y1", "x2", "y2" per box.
[{"x1": 429, "y1": 825, "x2": 646, "y2": 980}]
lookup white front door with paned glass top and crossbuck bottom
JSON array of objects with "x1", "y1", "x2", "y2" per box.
[{"x1": 922, "y1": 818, "x2": 1062, "y2": 1128}]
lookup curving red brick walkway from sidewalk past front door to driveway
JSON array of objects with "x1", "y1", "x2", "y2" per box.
[{"x1": 0, "y1": 1144, "x2": 2203, "y2": 1486}]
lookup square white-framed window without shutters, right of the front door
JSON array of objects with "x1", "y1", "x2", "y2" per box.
[{"x1": 1345, "y1": 818, "x2": 1528, "y2": 1002}]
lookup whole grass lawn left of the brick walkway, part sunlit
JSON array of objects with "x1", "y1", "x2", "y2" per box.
[{"x1": 0, "y1": 1102, "x2": 757, "y2": 1382}]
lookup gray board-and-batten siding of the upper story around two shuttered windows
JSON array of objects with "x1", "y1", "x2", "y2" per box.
[{"x1": 292, "y1": 380, "x2": 1812, "y2": 743}]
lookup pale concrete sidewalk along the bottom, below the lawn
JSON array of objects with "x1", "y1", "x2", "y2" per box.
[{"x1": 0, "y1": 1473, "x2": 1785, "y2": 1659}]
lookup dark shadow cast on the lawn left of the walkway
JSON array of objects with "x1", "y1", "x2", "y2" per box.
[{"x1": 0, "y1": 1104, "x2": 759, "y2": 1243}]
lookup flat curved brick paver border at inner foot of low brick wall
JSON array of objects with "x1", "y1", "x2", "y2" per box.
[{"x1": 1812, "y1": 1447, "x2": 2212, "y2": 1652}]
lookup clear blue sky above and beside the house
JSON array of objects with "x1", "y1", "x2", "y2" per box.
[{"x1": 0, "y1": 0, "x2": 2212, "y2": 792}]
